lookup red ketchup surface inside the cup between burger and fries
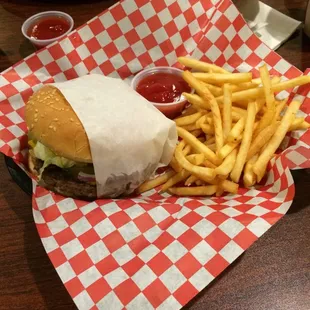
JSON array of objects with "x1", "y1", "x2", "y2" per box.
[{"x1": 136, "y1": 73, "x2": 191, "y2": 103}]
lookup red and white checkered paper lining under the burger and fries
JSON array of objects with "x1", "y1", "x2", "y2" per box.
[{"x1": 0, "y1": 0, "x2": 310, "y2": 310}]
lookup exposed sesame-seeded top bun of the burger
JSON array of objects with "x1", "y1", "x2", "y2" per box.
[{"x1": 25, "y1": 85, "x2": 92, "y2": 163}]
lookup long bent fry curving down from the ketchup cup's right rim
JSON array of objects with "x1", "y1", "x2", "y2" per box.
[{"x1": 182, "y1": 71, "x2": 224, "y2": 150}]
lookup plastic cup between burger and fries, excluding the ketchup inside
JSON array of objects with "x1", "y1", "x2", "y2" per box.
[{"x1": 131, "y1": 67, "x2": 194, "y2": 118}]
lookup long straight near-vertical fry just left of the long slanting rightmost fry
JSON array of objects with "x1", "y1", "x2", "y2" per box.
[{"x1": 230, "y1": 101, "x2": 256, "y2": 183}]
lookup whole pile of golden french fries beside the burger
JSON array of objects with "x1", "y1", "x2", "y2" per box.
[{"x1": 139, "y1": 57, "x2": 310, "y2": 196}]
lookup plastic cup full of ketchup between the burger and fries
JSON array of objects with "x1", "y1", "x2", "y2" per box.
[{"x1": 131, "y1": 67, "x2": 192, "y2": 118}]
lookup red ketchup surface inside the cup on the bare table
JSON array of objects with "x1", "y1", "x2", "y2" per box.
[{"x1": 27, "y1": 16, "x2": 70, "y2": 40}]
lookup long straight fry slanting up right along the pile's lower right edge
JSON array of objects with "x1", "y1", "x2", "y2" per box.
[{"x1": 253, "y1": 101, "x2": 301, "y2": 182}]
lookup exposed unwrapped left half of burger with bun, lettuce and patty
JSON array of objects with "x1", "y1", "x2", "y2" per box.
[{"x1": 25, "y1": 85, "x2": 97, "y2": 200}]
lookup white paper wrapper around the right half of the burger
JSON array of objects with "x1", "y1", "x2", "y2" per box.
[{"x1": 52, "y1": 74, "x2": 177, "y2": 197}]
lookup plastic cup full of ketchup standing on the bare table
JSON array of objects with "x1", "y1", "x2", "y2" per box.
[{"x1": 22, "y1": 11, "x2": 73, "y2": 48}]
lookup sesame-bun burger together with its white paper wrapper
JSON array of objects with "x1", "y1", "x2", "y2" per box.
[{"x1": 25, "y1": 74, "x2": 177, "y2": 200}]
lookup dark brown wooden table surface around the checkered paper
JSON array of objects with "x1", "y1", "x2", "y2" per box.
[{"x1": 0, "y1": 0, "x2": 310, "y2": 310}]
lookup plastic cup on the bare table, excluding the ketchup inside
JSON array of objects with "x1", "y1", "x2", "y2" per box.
[{"x1": 21, "y1": 11, "x2": 74, "y2": 49}]
